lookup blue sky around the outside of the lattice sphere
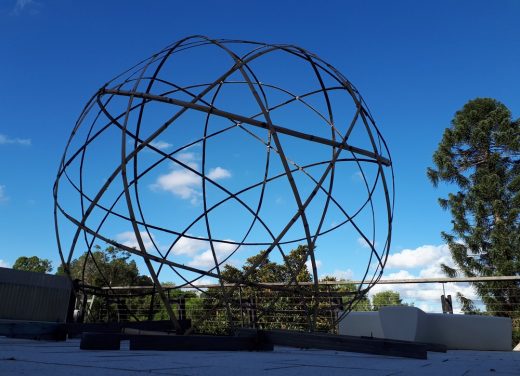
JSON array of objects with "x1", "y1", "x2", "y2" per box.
[{"x1": 0, "y1": 0, "x2": 520, "y2": 308}]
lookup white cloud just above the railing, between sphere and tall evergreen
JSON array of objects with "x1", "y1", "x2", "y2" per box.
[{"x1": 386, "y1": 244, "x2": 451, "y2": 269}]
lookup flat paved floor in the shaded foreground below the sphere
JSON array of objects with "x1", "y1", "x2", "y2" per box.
[{"x1": 0, "y1": 337, "x2": 520, "y2": 376}]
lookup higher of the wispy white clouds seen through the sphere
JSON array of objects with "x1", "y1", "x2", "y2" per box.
[{"x1": 151, "y1": 153, "x2": 231, "y2": 205}]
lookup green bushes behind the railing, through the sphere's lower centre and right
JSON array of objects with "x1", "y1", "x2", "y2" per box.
[{"x1": 190, "y1": 245, "x2": 370, "y2": 334}]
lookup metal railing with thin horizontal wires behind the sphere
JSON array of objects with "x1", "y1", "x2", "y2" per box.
[{"x1": 79, "y1": 276, "x2": 520, "y2": 332}]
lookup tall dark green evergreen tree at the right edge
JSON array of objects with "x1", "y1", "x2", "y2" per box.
[{"x1": 427, "y1": 98, "x2": 520, "y2": 317}]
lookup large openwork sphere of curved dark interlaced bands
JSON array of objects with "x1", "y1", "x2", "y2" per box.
[{"x1": 54, "y1": 36, "x2": 393, "y2": 326}]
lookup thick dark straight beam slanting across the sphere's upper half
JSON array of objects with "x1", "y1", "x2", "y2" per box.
[{"x1": 100, "y1": 88, "x2": 392, "y2": 166}]
